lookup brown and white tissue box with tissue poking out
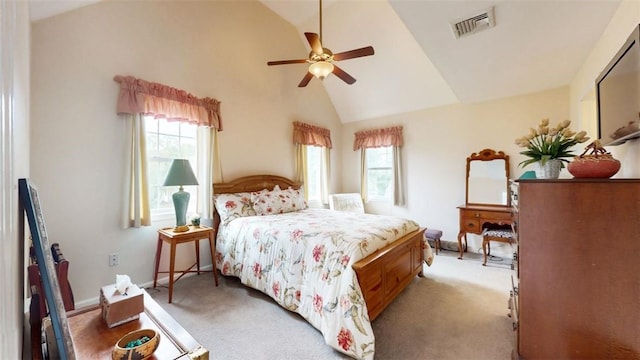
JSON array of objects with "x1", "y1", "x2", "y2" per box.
[{"x1": 100, "y1": 284, "x2": 144, "y2": 328}]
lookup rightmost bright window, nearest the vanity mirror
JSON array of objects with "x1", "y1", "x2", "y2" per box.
[{"x1": 365, "y1": 146, "x2": 393, "y2": 201}]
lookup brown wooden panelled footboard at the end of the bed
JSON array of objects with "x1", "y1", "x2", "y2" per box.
[{"x1": 353, "y1": 228, "x2": 425, "y2": 321}]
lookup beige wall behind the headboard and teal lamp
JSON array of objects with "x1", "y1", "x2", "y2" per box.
[{"x1": 31, "y1": 1, "x2": 341, "y2": 305}]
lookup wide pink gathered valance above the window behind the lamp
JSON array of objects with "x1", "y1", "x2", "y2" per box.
[{"x1": 113, "y1": 75, "x2": 222, "y2": 130}]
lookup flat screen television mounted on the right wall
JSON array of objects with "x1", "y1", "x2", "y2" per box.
[{"x1": 596, "y1": 26, "x2": 640, "y2": 145}]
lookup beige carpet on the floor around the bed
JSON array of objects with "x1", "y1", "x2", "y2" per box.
[{"x1": 148, "y1": 251, "x2": 513, "y2": 360}]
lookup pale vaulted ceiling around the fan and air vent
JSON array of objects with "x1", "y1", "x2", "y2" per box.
[{"x1": 31, "y1": 0, "x2": 620, "y2": 123}]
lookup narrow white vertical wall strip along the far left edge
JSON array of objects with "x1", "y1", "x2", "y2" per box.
[{"x1": 0, "y1": 1, "x2": 29, "y2": 359}]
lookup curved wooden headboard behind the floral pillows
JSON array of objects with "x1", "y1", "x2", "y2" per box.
[{"x1": 213, "y1": 175, "x2": 302, "y2": 233}]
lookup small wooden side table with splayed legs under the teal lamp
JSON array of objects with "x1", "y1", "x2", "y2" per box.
[{"x1": 153, "y1": 226, "x2": 218, "y2": 303}]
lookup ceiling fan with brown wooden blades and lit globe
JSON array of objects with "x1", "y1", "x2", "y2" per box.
[{"x1": 267, "y1": 0, "x2": 374, "y2": 87}]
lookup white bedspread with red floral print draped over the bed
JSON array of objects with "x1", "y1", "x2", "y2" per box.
[{"x1": 216, "y1": 209, "x2": 419, "y2": 359}]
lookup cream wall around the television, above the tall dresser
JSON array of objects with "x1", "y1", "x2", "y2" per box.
[{"x1": 570, "y1": 0, "x2": 640, "y2": 178}]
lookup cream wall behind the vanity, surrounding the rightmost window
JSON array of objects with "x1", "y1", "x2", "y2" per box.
[{"x1": 342, "y1": 87, "x2": 568, "y2": 255}]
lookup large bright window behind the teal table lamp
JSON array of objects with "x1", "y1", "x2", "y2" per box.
[{"x1": 145, "y1": 116, "x2": 198, "y2": 220}]
